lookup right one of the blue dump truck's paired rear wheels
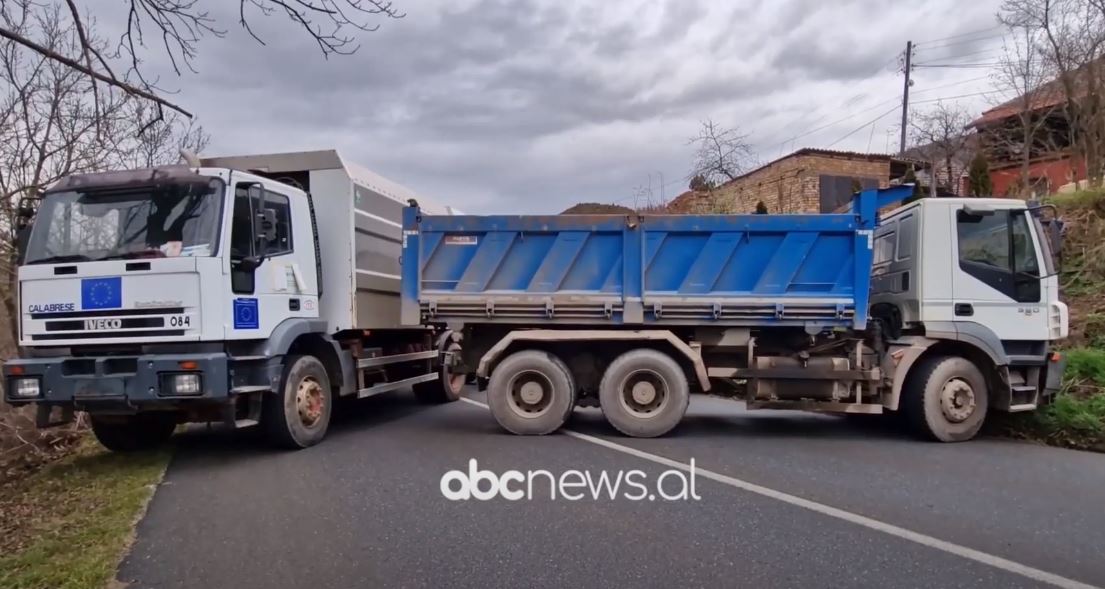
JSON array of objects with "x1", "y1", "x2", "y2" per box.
[{"x1": 599, "y1": 349, "x2": 691, "y2": 438}]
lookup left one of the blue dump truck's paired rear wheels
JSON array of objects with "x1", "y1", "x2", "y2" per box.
[{"x1": 487, "y1": 350, "x2": 576, "y2": 435}]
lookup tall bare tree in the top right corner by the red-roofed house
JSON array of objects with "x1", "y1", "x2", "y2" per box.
[{"x1": 999, "y1": 0, "x2": 1105, "y2": 186}]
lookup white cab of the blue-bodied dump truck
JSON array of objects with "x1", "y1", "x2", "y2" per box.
[{"x1": 871, "y1": 198, "x2": 1070, "y2": 411}]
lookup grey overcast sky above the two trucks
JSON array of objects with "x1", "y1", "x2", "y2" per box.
[{"x1": 131, "y1": 0, "x2": 1001, "y2": 213}]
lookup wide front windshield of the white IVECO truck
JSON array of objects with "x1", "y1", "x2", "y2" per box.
[{"x1": 24, "y1": 179, "x2": 223, "y2": 264}]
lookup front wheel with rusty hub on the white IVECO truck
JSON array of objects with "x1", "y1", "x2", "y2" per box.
[{"x1": 261, "y1": 356, "x2": 334, "y2": 450}]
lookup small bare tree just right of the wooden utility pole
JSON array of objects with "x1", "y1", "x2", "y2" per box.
[{"x1": 909, "y1": 102, "x2": 971, "y2": 194}]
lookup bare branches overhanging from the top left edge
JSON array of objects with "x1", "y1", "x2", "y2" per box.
[{"x1": 0, "y1": 0, "x2": 404, "y2": 128}]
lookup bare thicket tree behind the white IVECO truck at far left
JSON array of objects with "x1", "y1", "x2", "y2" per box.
[{"x1": 0, "y1": 3, "x2": 208, "y2": 347}]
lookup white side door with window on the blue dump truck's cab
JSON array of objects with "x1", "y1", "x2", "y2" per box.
[{"x1": 953, "y1": 207, "x2": 1048, "y2": 341}]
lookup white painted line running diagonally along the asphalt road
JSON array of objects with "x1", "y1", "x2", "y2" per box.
[{"x1": 461, "y1": 398, "x2": 1099, "y2": 589}]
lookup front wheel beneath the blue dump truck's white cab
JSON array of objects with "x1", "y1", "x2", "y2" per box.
[{"x1": 901, "y1": 356, "x2": 989, "y2": 442}]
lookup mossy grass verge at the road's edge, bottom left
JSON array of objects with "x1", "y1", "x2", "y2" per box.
[{"x1": 0, "y1": 441, "x2": 169, "y2": 589}]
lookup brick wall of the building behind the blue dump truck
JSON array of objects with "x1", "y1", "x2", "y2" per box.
[{"x1": 715, "y1": 155, "x2": 890, "y2": 213}]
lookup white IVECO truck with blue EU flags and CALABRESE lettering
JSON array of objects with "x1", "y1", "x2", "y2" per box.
[{"x1": 4, "y1": 150, "x2": 464, "y2": 451}]
